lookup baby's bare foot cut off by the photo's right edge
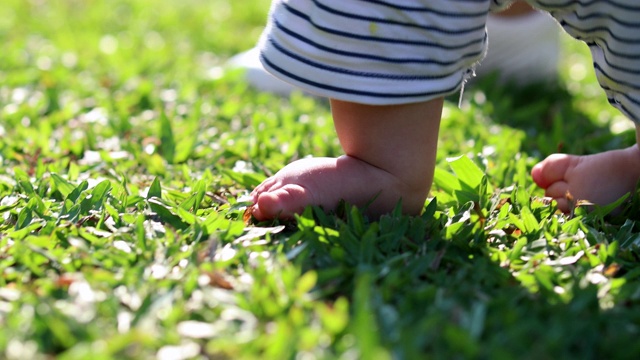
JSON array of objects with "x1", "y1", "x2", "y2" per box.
[{"x1": 531, "y1": 145, "x2": 640, "y2": 212}]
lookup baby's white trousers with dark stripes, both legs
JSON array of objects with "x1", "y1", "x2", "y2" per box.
[{"x1": 260, "y1": 0, "x2": 640, "y2": 123}]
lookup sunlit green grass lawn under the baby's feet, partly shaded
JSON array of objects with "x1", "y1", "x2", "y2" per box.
[{"x1": 0, "y1": 0, "x2": 640, "y2": 359}]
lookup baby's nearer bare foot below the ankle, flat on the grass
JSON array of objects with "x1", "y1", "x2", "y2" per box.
[{"x1": 251, "y1": 156, "x2": 430, "y2": 221}]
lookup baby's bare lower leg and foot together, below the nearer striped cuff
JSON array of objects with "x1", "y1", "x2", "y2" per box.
[{"x1": 252, "y1": 99, "x2": 443, "y2": 221}]
